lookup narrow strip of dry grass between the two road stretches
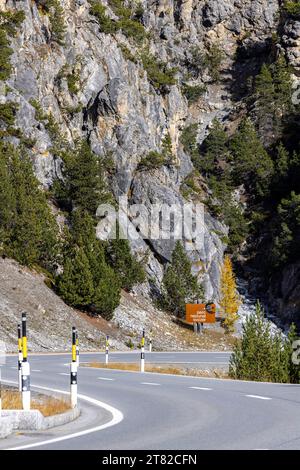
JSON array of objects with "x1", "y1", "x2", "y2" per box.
[{"x1": 81, "y1": 362, "x2": 229, "y2": 379}]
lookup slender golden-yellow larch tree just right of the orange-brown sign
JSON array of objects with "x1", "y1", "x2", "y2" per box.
[{"x1": 220, "y1": 255, "x2": 240, "y2": 332}]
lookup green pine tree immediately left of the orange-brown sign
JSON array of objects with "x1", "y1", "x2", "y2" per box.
[{"x1": 162, "y1": 241, "x2": 204, "y2": 317}]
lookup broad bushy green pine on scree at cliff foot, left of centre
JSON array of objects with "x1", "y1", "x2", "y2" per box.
[{"x1": 57, "y1": 209, "x2": 121, "y2": 320}]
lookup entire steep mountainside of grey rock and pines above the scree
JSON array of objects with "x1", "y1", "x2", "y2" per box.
[{"x1": 0, "y1": 0, "x2": 300, "y2": 323}]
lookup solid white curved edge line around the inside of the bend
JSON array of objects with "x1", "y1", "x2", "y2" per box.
[{"x1": 6, "y1": 381, "x2": 124, "y2": 450}]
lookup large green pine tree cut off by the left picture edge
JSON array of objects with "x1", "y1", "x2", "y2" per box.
[{"x1": 0, "y1": 142, "x2": 59, "y2": 270}]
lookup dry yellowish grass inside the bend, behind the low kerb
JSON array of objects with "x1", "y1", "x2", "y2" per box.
[{"x1": 2, "y1": 389, "x2": 71, "y2": 417}]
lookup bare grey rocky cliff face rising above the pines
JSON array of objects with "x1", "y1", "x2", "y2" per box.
[{"x1": 0, "y1": 0, "x2": 299, "y2": 304}]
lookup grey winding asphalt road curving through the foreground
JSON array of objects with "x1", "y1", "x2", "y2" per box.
[{"x1": 0, "y1": 352, "x2": 300, "y2": 450}]
